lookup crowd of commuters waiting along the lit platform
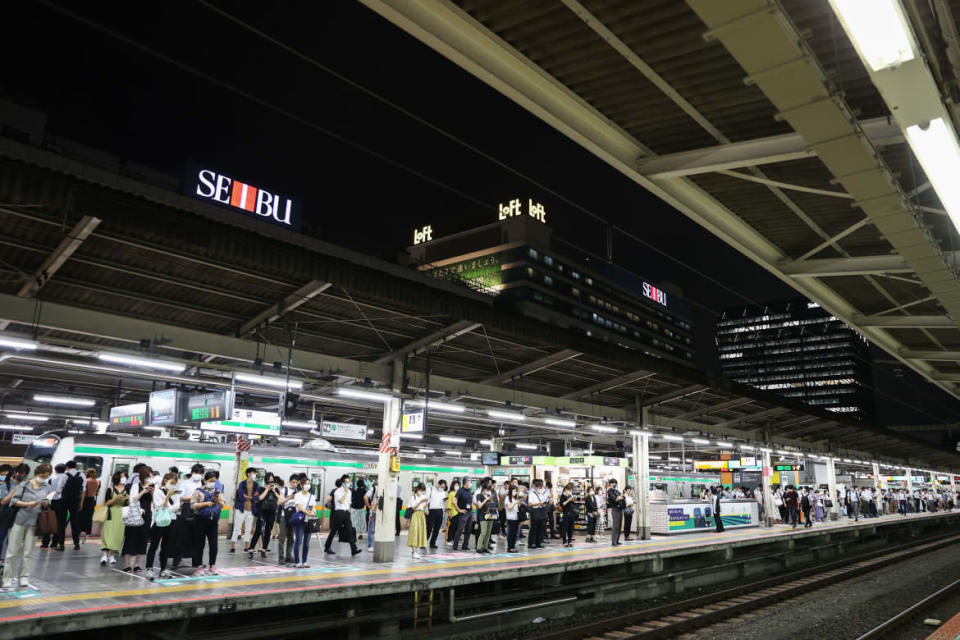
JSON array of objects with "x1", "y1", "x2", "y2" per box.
[{"x1": 0, "y1": 461, "x2": 955, "y2": 590}]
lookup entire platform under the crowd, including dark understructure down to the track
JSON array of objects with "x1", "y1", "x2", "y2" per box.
[{"x1": 0, "y1": 511, "x2": 960, "y2": 640}]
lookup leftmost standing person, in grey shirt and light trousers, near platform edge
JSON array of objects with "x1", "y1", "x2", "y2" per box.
[{"x1": 2, "y1": 462, "x2": 53, "y2": 591}]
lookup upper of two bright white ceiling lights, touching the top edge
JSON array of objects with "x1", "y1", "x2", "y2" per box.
[{"x1": 830, "y1": 0, "x2": 916, "y2": 71}]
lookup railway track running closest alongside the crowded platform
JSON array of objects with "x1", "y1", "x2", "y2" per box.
[{"x1": 538, "y1": 534, "x2": 960, "y2": 640}]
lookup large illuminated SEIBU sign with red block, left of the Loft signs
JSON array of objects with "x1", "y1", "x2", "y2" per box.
[{"x1": 183, "y1": 164, "x2": 299, "y2": 228}]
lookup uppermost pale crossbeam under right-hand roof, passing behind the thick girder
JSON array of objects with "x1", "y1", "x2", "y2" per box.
[{"x1": 639, "y1": 118, "x2": 903, "y2": 178}]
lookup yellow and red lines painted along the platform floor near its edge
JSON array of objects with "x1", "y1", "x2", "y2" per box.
[{"x1": 0, "y1": 519, "x2": 944, "y2": 622}]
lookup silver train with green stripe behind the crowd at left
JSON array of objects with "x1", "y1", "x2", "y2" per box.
[{"x1": 23, "y1": 431, "x2": 484, "y2": 531}]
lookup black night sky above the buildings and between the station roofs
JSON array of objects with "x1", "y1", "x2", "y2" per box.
[{"x1": 0, "y1": 0, "x2": 960, "y2": 430}]
